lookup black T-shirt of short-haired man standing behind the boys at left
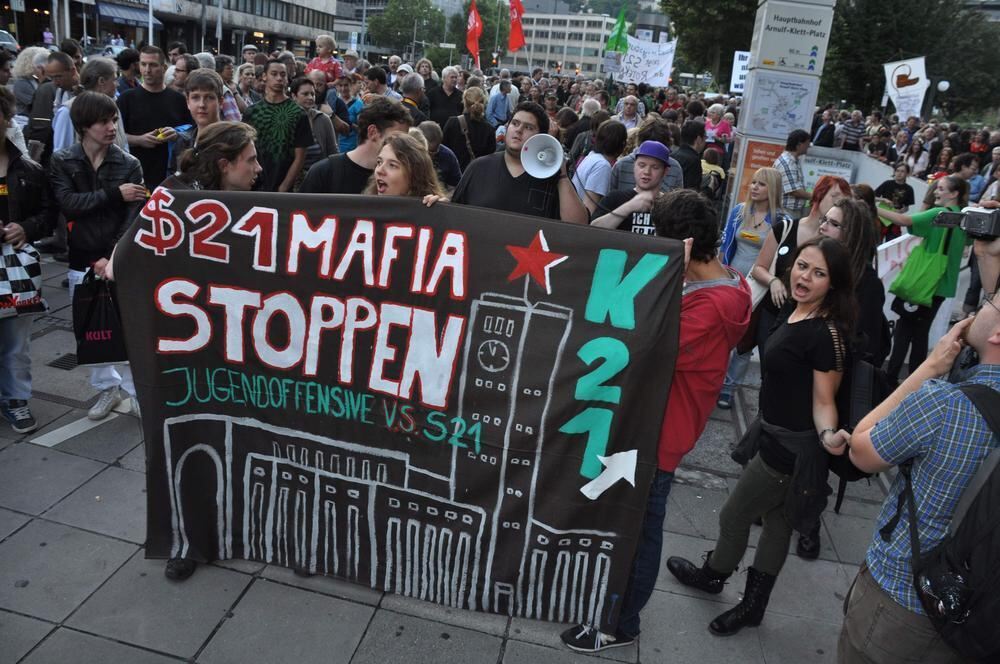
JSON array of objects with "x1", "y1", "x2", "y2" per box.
[{"x1": 118, "y1": 85, "x2": 194, "y2": 191}]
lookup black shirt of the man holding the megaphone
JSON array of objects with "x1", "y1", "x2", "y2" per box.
[{"x1": 452, "y1": 152, "x2": 559, "y2": 219}]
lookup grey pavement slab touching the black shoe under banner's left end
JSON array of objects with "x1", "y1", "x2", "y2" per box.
[{"x1": 66, "y1": 554, "x2": 252, "y2": 658}]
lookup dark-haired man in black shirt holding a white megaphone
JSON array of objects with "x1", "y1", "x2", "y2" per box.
[{"x1": 452, "y1": 101, "x2": 588, "y2": 224}]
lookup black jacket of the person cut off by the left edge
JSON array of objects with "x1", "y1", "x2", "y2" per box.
[{"x1": 0, "y1": 139, "x2": 57, "y2": 242}]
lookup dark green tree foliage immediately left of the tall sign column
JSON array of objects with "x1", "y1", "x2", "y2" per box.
[{"x1": 660, "y1": 0, "x2": 757, "y2": 87}]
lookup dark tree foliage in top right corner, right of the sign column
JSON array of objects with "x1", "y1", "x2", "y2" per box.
[{"x1": 820, "y1": 0, "x2": 1000, "y2": 117}]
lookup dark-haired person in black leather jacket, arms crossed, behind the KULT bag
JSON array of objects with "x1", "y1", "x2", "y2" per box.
[{"x1": 51, "y1": 92, "x2": 146, "y2": 420}]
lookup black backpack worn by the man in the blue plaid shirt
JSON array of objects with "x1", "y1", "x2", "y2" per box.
[{"x1": 879, "y1": 383, "x2": 1000, "y2": 661}]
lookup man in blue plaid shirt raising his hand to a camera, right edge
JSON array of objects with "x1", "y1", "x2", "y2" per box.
[{"x1": 838, "y1": 231, "x2": 1000, "y2": 664}]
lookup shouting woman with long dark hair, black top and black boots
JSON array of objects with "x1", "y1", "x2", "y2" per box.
[{"x1": 667, "y1": 237, "x2": 856, "y2": 636}]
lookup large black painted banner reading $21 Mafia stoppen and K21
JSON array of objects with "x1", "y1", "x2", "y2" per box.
[{"x1": 115, "y1": 190, "x2": 683, "y2": 628}]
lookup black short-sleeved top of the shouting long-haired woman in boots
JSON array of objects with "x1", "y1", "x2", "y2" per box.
[{"x1": 760, "y1": 318, "x2": 846, "y2": 474}]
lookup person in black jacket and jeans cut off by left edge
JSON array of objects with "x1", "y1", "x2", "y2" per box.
[{"x1": 0, "y1": 88, "x2": 55, "y2": 433}]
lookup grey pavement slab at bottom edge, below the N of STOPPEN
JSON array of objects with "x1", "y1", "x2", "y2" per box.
[{"x1": 351, "y1": 610, "x2": 503, "y2": 664}]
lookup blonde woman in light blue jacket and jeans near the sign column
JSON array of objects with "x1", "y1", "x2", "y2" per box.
[{"x1": 718, "y1": 168, "x2": 792, "y2": 409}]
